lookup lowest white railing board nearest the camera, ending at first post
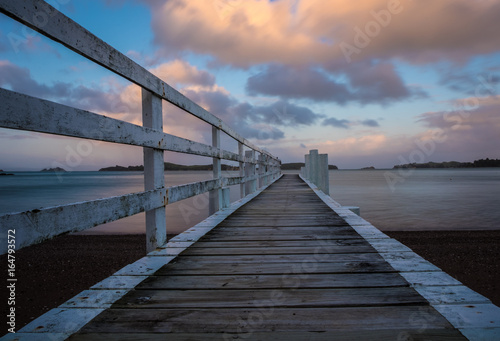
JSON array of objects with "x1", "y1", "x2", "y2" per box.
[{"x1": 0, "y1": 188, "x2": 166, "y2": 253}]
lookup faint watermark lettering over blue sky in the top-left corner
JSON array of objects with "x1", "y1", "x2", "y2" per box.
[{"x1": 7, "y1": 0, "x2": 70, "y2": 53}]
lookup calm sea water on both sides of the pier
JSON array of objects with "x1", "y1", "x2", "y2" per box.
[{"x1": 0, "y1": 168, "x2": 500, "y2": 233}]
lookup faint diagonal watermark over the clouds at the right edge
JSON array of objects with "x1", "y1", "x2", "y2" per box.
[{"x1": 384, "y1": 74, "x2": 497, "y2": 192}]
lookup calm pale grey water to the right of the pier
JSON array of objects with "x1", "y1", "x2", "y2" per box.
[{"x1": 330, "y1": 168, "x2": 500, "y2": 230}]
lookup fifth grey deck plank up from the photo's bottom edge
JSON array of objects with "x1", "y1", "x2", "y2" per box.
[{"x1": 155, "y1": 254, "x2": 395, "y2": 275}]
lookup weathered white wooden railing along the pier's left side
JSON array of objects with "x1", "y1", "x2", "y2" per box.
[{"x1": 0, "y1": 0, "x2": 281, "y2": 253}]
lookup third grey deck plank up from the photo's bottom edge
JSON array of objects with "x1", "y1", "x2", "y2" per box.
[{"x1": 111, "y1": 287, "x2": 427, "y2": 309}]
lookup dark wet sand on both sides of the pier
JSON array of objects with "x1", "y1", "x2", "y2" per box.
[{"x1": 0, "y1": 231, "x2": 500, "y2": 335}]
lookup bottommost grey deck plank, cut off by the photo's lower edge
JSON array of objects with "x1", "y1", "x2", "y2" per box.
[{"x1": 70, "y1": 327, "x2": 468, "y2": 341}]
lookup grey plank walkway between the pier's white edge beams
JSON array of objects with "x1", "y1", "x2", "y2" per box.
[{"x1": 70, "y1": 175, "x2": 465, "y2": 341}]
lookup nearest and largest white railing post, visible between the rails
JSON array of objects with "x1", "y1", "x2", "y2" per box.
[{"x1": 142, "y1": 88, "x2": 167, "y2": 252}]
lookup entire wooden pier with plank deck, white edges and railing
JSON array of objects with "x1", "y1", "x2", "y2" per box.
[{"x1": 0, "y1": 0, "x2": 500, "y2": 341}]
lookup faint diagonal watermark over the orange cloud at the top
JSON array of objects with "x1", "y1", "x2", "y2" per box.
[{"x1": 340, "y1": 0, "x2": 412, "y2": 63}]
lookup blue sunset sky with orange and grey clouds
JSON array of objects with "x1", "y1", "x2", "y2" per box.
[{"x1": 0, "y1": 0, "x2": 500, "y2": 171}]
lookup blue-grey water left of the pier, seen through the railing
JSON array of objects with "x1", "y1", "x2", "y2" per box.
[{"x1": 0, "y1": 171, "x2": 239, "y2": 233}]
